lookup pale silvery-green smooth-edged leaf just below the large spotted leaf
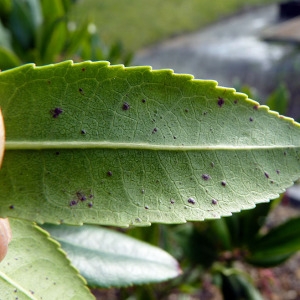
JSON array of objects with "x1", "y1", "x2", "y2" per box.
[{"x1": 43, "y1": 225, "x2": 181, "y2": 287}]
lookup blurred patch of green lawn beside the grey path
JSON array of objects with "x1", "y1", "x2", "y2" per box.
[{"x1": 74, "y1": 0, "x2": 278, "y2": 51}]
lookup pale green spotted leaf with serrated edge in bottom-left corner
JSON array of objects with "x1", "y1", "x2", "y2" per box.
[{"x1": 0, "y1": 219, "x2": 94, "y2": 300}]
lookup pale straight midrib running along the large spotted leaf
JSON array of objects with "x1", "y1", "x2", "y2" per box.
[{"x1": 5, "y1": 141, "x2": 300, "y2": 151}]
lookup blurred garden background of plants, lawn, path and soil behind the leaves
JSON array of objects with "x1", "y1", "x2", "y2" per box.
[{"x1": 0, "y1": 0, "x2": 300, "y2": 300}]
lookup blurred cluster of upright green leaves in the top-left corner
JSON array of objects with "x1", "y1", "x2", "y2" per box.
[{"x1": 0, "y1": 0, "x2": 132, "y2": 70}]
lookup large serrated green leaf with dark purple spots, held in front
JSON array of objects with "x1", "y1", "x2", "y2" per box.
[{"x1": 0, "y1": 61, "x2": 300, "y2": 226}]
